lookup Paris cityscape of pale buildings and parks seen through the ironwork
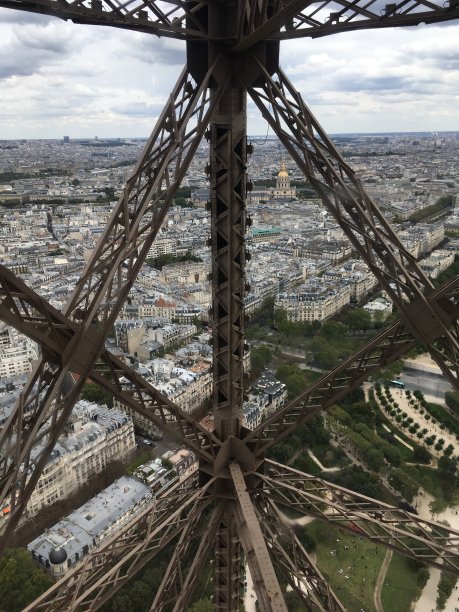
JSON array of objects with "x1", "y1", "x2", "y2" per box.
[{"x1": 0, "y1": 132, "x2": 459, "y2": 611}]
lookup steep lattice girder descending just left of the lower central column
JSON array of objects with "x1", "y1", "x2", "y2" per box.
[{"x1": 150, "y1": 502, "x2": 225, "y2": 612}]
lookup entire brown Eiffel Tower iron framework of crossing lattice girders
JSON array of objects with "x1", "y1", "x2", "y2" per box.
[{"x1": 0, "y1": 0, "x2": 459, "y2": 612}]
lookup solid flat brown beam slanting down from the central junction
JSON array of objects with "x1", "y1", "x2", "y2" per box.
[{"x1": 229, "y1": 463, "x2": 287, "y2": 612}]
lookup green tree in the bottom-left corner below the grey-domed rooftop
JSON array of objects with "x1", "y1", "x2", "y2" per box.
[{"x1": 0, "y1": 548, "x2": 54, "y2": 612}]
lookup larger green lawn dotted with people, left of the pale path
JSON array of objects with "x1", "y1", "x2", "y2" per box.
[{"x1": 305, "y1": 521, "x2": 386, "y2": 612}]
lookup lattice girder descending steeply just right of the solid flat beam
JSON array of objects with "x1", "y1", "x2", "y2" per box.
[{"x1": 255, "y1": 498, "x2": 346, "y2": 612}]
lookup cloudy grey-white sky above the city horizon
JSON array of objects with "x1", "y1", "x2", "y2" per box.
[{"x1": 0, "y1": 9, "x2": 459, "y2": 139}]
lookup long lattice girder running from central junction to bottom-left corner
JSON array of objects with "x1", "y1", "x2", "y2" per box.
[{"x1": 24, "y1": 475, "x2": 214, "y2": 612}]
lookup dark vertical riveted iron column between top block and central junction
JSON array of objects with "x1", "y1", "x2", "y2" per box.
[{"x1": 210, "y1": 88, "x2": 246, "y2": 440}]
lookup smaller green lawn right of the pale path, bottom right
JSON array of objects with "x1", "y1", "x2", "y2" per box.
[{"x1": 381, "y1": 553, "x2": 422, "y2": 612}]
